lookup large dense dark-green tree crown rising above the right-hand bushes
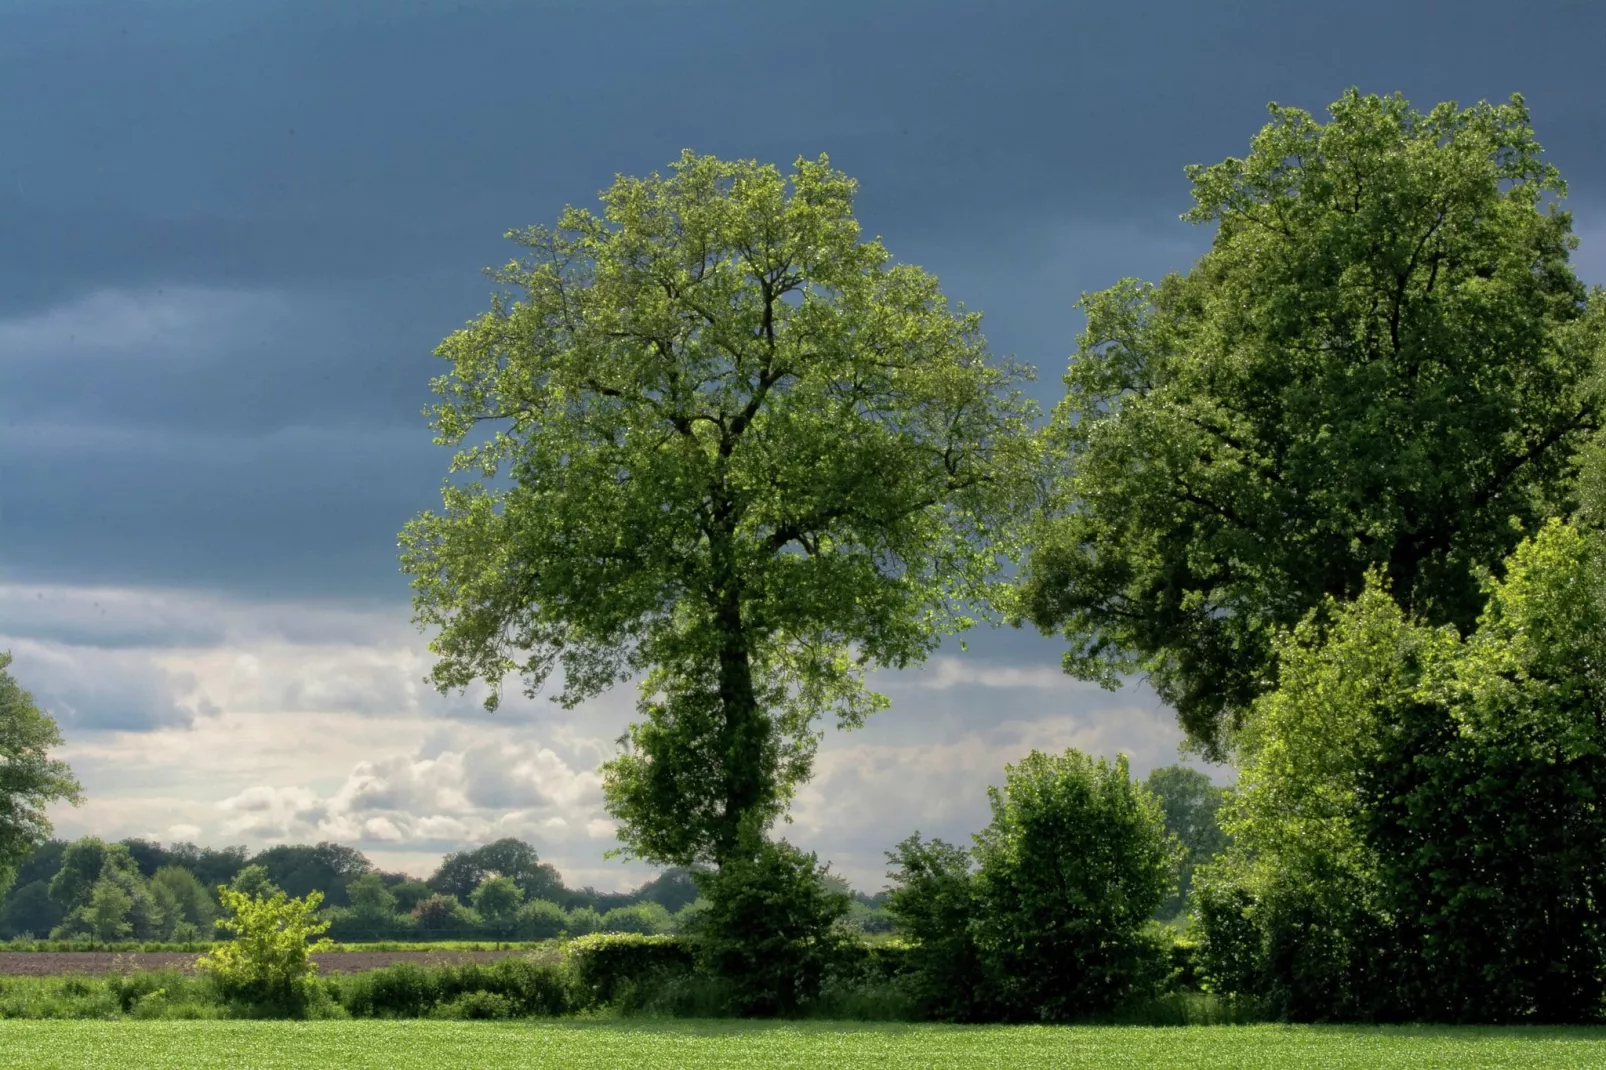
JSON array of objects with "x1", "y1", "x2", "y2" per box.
[{"x1": 1018, "y1": 90, "x2": 1606, "y2": 753}]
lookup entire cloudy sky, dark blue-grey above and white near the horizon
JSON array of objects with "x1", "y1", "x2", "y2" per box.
[{"x1": 0, "y1": 0, "x2": 1606, "y2": 890}]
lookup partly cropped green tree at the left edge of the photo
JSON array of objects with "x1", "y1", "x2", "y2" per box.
[{"x1": 0, "y1": 652, "x2": 80, "y2": 893}]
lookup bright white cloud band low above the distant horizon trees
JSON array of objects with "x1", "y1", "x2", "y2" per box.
[{"x1": 25, "y1": 585, "x2": 1207, "y2": 888}]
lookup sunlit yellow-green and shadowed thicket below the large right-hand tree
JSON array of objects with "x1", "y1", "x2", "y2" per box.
[{"x1": 1200, "y1": 522, "x2": 1606, "y2": 1022}]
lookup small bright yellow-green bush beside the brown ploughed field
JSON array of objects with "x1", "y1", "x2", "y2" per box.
[{"x1": 196, "y1": 885, "x2": 331, "y2": 1009}]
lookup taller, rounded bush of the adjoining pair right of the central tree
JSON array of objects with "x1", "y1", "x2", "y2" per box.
[{"x1": 973, "y1": 750, "x2": 1180, "y2": 1020}]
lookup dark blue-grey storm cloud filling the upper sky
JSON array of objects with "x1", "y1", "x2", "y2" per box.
[{"x1": 0, "y1": 0, "x2": 1606, "y2": 604}]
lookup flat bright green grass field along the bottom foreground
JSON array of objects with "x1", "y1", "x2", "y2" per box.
[{"x1": 0, "y1": 1022, "x2": 1606, "y2": 1070}]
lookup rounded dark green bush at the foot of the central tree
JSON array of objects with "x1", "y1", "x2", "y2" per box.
[{"x1": 689, "y1": 842, "x2": 851, "y2": 1015}]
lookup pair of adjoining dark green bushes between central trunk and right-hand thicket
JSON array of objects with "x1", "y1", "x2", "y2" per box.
[{"x1": 887, "y1": 750, "x2": 1180, "y2": 1022}]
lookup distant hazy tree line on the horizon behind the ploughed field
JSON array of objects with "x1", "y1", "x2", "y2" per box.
[{"x1": 0, "y1": 837, "x2": 891, "y2": 941}]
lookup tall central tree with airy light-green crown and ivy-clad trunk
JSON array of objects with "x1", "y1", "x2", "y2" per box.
[{"x1": 402, "y1": 153, "x2": 1036, "y2": 864}]
